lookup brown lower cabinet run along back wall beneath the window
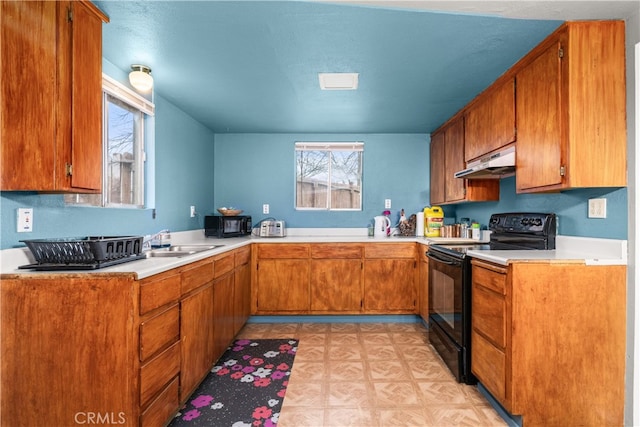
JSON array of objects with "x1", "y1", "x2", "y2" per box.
[{"x1": 252, "y1": 242, "x2": 418, "y2": 314}]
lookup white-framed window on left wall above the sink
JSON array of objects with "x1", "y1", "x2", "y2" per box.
[{"x1": 65, "y1": 75, "x2": 154, "y2": 208}]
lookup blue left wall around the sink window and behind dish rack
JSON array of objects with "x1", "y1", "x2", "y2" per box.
[{"x1": 0, "y1": 96, "x2": 214, "y2": 249}]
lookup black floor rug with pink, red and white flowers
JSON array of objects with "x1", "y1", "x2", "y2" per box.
[{"x1": 169, "y1": 339, "x2": 298, "y2": 427}]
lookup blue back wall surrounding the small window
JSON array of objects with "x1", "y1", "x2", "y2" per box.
[{"x1": 214, "y1": 134, "x2": 429, "y2": 228}]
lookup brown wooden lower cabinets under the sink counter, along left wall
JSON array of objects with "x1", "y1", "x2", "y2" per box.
[{"x1": 0, "y1": 246, "x2": 251, "y2": 427}]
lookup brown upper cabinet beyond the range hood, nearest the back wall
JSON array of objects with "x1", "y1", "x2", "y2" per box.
[{"x1": 431, "y1": 116, "x2": 500, "y2": 205}]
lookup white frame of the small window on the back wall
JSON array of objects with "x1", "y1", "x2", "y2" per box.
[{"x1": 293, "y1": 141, "x2": 364, "y2": 212}]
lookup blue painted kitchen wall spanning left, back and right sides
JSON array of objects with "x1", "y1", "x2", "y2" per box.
[{"x1": 0, "y1": 112, "x2": 628, "y2": 249}]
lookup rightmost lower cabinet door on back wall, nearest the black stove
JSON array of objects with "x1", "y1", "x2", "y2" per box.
[{"x1": 364, "y1": 259, "x2": 416, "y2": 313}]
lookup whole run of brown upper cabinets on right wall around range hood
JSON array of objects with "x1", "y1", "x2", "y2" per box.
[{"x1": 431, "y1": 21, "x2": 627, "y2": 204}]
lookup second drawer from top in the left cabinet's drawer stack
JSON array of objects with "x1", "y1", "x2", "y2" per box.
[{"x1": 140, "y1": 304, "x2": 180, "y2": 362}]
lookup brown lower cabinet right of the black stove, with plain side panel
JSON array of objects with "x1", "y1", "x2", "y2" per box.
[{"x1": 471, "y1": 260, "x2": 626, "y2": 427}]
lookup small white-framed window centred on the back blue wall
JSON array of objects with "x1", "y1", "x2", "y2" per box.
[{"x1": 295, "y1": 142, "x2": 364, "y2": 210}]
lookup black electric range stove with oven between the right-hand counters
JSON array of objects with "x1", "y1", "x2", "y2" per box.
[{"x1": 427, "y1": 213, "x2": 556, "y2": 384}]
